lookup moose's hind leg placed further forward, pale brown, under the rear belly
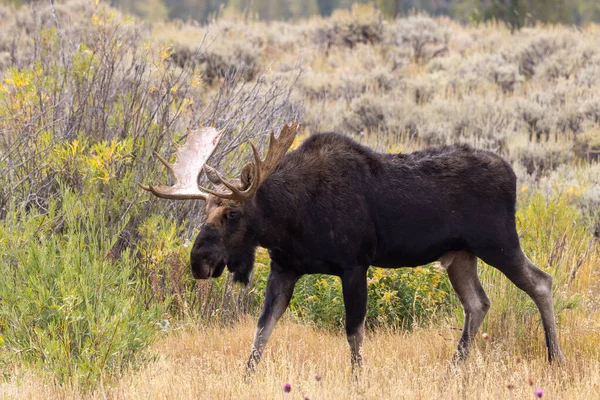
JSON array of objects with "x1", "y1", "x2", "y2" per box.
[{"x1": 440, "y1": 252, "x2": 490, "y2": 363}]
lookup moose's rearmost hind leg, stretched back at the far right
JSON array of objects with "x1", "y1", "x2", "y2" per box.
[{"x1": 483, "y1": 248, "x2": 565, "y2": 363}]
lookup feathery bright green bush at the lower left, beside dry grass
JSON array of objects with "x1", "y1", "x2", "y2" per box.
[{"x1": 0, "y1": 188, "x2": 163, "y2": 387}]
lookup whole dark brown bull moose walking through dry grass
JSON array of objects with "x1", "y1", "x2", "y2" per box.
[{"x1": 141, "y1": 122, "x2": 564, "y2": 370}]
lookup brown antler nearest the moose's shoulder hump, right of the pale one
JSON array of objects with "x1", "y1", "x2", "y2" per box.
[{"x1": 202, "y1": 122, "x2": 300, "y2": 201}]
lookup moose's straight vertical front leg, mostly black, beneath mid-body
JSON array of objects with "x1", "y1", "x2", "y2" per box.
[{"x1": 342, "y1": 268, "x2": 367, "y2": 371}]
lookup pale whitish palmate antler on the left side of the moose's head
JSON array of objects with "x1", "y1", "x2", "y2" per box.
[{"x1": 140, "y1": 128, "x2": 221, "y2": 200}]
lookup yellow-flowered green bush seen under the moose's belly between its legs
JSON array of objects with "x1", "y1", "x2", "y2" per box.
[{"x1": 248, "y1": 250, "x2": 450, "y2": 329}]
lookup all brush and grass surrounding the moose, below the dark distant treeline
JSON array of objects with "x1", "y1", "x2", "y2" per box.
[{"x1": 0, "y1": 0, "x2": 600, "y2": 399}]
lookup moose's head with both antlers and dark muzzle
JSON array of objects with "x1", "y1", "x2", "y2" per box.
[{"x1": 140, "y1": 122, "x2": 300, "y2": 284}]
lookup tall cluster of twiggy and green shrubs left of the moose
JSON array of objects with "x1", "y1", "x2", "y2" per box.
[{"x1": 0, "y1": 3, "x2": 301, "y2": 388}]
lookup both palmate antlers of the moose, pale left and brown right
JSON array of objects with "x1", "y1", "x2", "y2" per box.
[{"x1": 140, "y1": 122, "x2": 300, "y2": 201}]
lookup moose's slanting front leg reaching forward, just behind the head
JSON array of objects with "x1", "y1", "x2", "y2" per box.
[{"x1": 248, "y1": 263, "x2": 300, "y2": 371}]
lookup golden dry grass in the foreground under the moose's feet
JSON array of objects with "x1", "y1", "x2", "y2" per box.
[{"x1": 0, "y1": 306, "x2": 600, "y2": 399}]
